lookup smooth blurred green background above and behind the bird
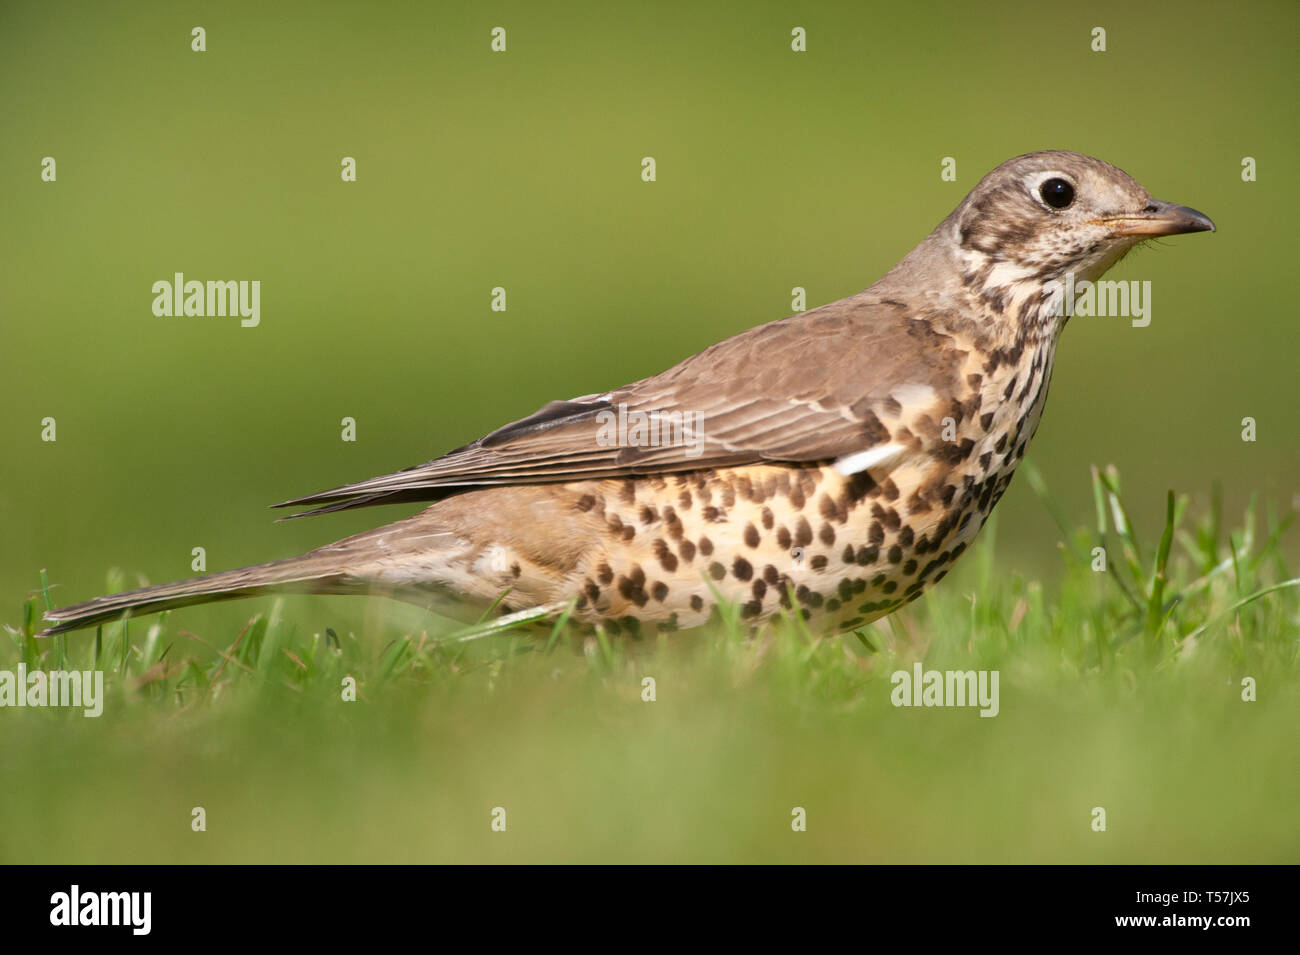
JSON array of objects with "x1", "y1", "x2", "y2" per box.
[{"x1": 0, "y1": 0, "x2": 1300, "y2": 858}]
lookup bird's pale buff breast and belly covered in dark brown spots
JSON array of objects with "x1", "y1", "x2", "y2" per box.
[{"x1": 384, "y1": 355, "x2": 1050, "y2": 634}]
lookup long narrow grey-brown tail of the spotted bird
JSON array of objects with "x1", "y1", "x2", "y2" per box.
[{"x1": 39, "y1": 548, "x2": 368, "y2": 637}]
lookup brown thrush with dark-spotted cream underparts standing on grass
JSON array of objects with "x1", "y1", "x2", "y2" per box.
[{"x1": 42, "y1": 149, "x2": 1216, "y2": 637}]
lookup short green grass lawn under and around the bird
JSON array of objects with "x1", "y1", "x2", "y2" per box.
[{"x1": 0, "y1": 466, "x2": 1300, "y2": 863}]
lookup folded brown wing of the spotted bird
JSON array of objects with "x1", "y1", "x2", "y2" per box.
[{"x1": 274, "y1": 294, "x2": 959, "y2": 517}]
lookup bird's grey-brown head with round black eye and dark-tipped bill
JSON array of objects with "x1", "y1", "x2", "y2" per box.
[{"x1": 940, "y1": 149, "x2": 1214, "y2": 320}]
